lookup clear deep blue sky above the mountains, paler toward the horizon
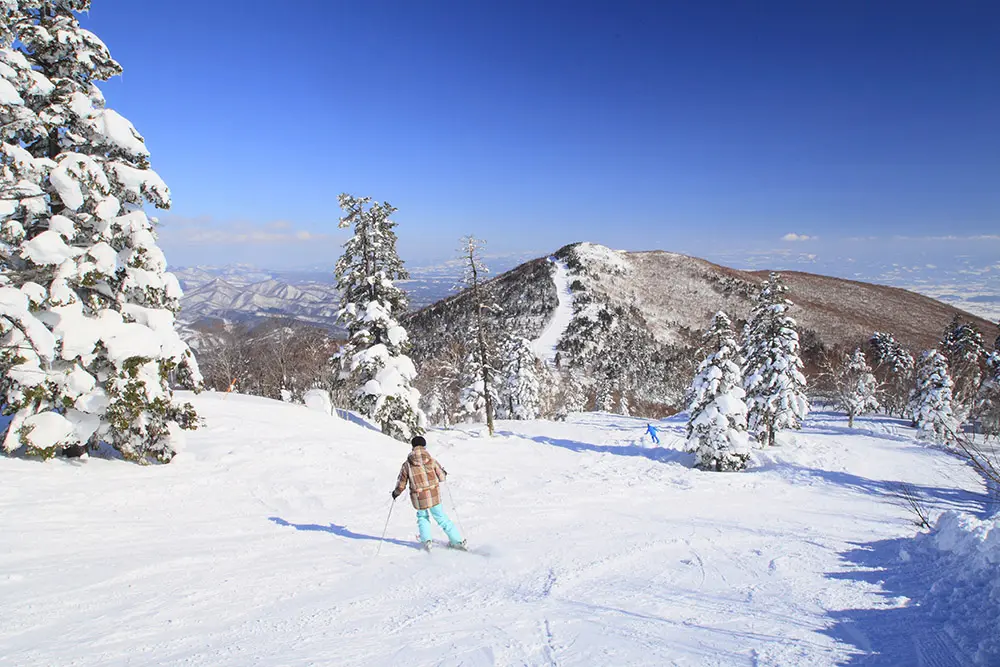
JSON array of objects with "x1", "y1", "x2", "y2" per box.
[{"x1": 82, "y1": 0, "x2": 1000, "y2": 267}]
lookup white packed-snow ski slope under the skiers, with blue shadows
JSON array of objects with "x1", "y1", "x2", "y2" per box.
[{"x1": 0, "y1": 394, "x2": 985, "y2": 667}]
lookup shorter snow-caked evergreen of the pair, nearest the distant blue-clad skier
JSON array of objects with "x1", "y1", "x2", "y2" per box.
[{"x1": 687, "y1": 312, "x2": 750, "y2": 472}]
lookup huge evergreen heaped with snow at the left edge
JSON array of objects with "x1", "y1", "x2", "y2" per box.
[{"x1": 0, "y1": 0, "x2": 201, "y2": 463}]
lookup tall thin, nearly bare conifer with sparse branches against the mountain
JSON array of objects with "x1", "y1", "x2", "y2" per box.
[{"x1": 459, "y1": 236, "x2": 502, "y2": 436}]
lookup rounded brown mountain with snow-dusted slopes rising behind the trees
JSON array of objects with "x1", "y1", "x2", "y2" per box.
[{"x1": 404, "y1": 243, "x2": 998, "y2": 403}]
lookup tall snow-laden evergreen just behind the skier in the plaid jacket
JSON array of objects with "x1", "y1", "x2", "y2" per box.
[{"x1": 336, "y1": 194, "x2": 426, "y2": 442}]
